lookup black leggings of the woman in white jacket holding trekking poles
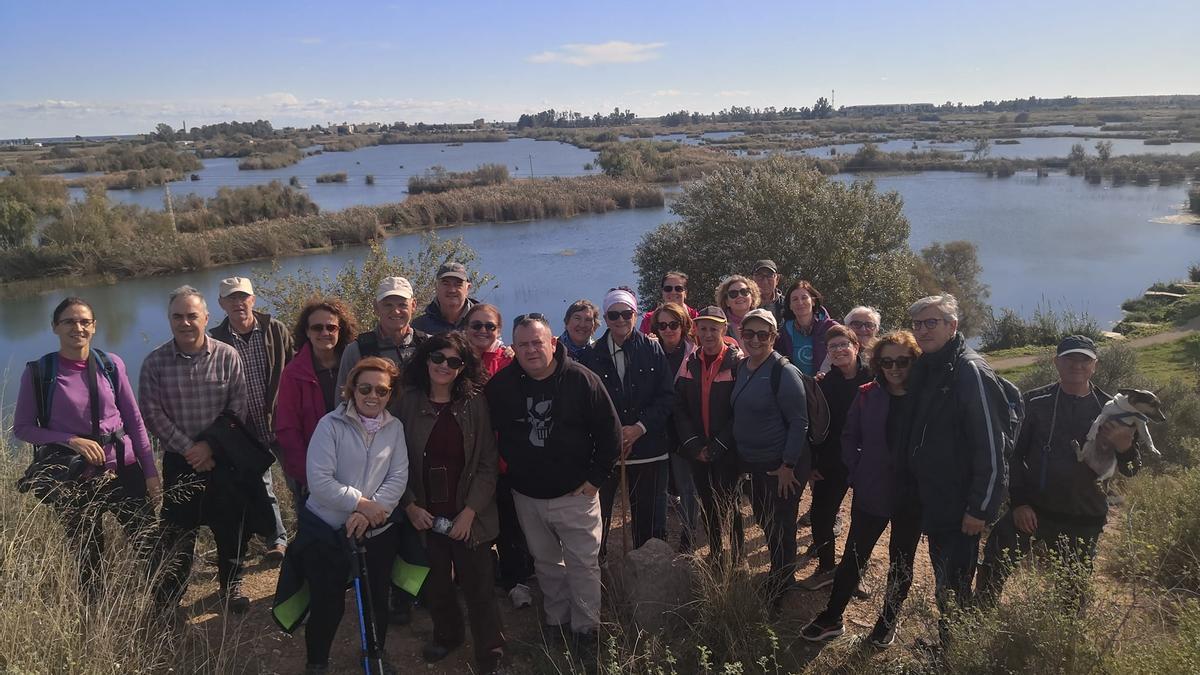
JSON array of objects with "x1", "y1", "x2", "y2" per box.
[{"x1": 304, "y1": 525, "x2": 396, "y2": 665}]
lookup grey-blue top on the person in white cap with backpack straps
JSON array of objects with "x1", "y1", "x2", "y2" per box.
[{"x1": 730, "y1": 352, "x2": 811, "y2": 471}]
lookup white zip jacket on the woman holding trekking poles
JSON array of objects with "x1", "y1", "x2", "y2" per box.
[{"x1": 306, "y1": 401, "x2": 408, "y2": 536}]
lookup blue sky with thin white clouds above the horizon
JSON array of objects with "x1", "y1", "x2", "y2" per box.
[{"x1": 0, "y1": 0, "x2": 1200, "y2": 138}]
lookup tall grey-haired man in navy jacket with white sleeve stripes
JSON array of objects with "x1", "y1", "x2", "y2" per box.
[{"x1": 907, "y1": 294, "x2": 1010, "y2": 639}]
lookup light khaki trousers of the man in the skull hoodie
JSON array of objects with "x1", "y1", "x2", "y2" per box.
[{"x1": 512, "y1": 490, "x2": 601, "y2": 633}]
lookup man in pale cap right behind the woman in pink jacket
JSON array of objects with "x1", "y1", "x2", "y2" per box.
[{"x1": 337, "y1": 276, "x2": 428, "y2": 392}]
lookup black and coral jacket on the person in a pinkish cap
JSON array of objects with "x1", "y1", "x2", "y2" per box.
[{"x1": 671, "y1": 346, "x2": 742, "y2": 461}]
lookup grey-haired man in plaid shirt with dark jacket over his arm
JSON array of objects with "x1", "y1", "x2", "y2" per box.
[{"x1": 138, "y1": 286, "x2": 250, "y2": 614}]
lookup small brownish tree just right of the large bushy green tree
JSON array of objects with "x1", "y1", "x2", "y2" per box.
[{"x1": 917, "y1": 241, "x2": 991, "y2": 338}]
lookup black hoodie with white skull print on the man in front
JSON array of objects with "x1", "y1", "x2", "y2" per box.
[{"x1": 484, "y1": 342, "x2": 620, "y2": 500}]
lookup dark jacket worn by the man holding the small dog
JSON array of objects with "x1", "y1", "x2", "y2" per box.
[{"x1": 1010, "y1": 383, "x2": 1141, "y2": 526}]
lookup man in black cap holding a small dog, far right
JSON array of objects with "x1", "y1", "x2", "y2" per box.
[{"x1": 977, "y1": 335, "x2": 1141, "y2": 602}]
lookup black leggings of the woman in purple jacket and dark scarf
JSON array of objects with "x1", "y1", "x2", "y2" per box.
[{"x1": 814, "y1": 508, "x2": 920, "y2": 626}]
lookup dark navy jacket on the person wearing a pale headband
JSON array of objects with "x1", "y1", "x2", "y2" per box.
[{"x1": 580, "y1": 330, "x2": 674, "y2": 459}]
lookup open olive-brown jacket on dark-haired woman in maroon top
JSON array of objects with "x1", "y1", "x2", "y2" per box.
[{"x1": 395, "y1": 388, "x2": 500, "y2": 548}]
